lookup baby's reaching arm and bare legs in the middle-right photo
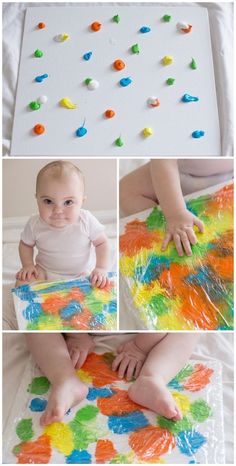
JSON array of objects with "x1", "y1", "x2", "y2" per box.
[{"x1": 120, "y1": 158, "x2": 233, "y2": 256}]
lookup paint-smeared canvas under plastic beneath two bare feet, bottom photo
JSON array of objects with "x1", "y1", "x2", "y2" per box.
[{"x1": 4, "y1": 353, "x2": 224, "y2": 464}]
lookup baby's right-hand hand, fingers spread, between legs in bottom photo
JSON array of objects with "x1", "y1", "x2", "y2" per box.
[{"x1": 112, "y1": 340, "x2": 147, "y2": 380}]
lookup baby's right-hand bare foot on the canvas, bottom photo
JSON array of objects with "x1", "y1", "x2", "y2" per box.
[{"x1": 129, "y1": 375, "x2": 182, "y2": 421}]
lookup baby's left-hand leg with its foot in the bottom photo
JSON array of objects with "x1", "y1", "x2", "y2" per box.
[{"x1": 26, "y1": 333, "x2": 88, "y2": 425}]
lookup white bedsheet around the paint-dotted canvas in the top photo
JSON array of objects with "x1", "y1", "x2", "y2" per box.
[{"x1": 3, "y1": 2, "x2": 233, "y2": 156}]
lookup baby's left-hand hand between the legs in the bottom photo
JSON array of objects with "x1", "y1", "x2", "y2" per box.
[{"x1": 66, "y1": 333, "x2": 94, "y2": 369}]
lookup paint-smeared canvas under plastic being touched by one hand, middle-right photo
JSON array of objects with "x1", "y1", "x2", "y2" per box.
[{"x1": 120, "y1": 183, "x2": 233, "y2": 330}]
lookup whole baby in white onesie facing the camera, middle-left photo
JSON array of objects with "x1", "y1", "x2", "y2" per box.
[{"x1": 16, "y1": 161, "x2": 109, "y2": 288}]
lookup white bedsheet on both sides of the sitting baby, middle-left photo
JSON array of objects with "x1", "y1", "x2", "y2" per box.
[{"x1": 2, "y1": 211, "x2": 117, "y2": 330}]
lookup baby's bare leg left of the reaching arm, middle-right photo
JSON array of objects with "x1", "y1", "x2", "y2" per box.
[{"x1": 120, "y1": 162, "x2": 158, "y2": 215}]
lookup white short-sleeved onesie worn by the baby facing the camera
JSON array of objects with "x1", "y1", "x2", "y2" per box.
[{"x1": 21, "y1": 209, "x2": 105, "y2": 280}]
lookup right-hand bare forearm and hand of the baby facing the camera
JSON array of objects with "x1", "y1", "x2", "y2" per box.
[{"x1": 90, "y1": 233, "x2": 109, "y2": 288}]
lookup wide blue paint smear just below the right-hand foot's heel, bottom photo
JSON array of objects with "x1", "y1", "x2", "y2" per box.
[{"x1": 108, "y1": 411, "x2": 150, "y2": 434}]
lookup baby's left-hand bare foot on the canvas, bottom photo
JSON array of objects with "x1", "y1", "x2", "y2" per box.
[{"x1": 40, "y1": 375, "x2": 88, "y2": 426}]
